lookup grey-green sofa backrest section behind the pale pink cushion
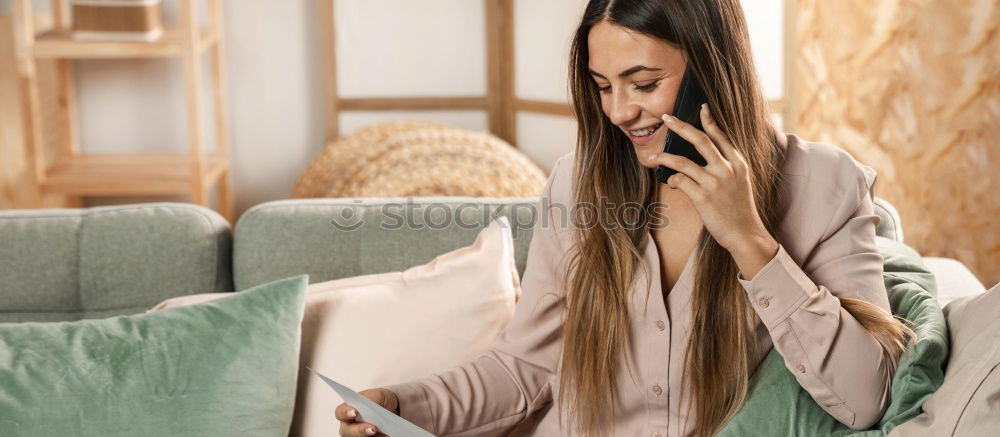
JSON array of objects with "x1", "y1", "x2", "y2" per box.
[{"x1": 233, "y1": 197, "x2": 538, "y2": 290}]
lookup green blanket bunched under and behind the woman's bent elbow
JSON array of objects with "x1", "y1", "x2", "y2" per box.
[{"x1": 718, "y1": 237, "x2": 948, "y2": 437}]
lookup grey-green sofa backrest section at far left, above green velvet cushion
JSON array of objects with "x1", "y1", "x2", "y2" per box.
[{"x1": 0, "y1": 203, "x2": 232, "y2": 322}]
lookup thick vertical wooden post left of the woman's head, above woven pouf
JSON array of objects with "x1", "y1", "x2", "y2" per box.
[{"x1": 485, "y1": 0, "x2": 517, "y2": 147}]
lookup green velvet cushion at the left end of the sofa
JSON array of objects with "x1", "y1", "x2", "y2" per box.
[{"x1": 0, "y1": 275, "x2": 308, "y2": 437}]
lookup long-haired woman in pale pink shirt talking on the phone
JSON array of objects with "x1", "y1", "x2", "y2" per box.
[{"x1": 335, "y1": 0, "x2": 912, "y2": 437}]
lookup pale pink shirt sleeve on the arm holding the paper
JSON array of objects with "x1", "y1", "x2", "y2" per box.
[{"x1": 385, "y1": 157, "x2": 570, "y2": 436}]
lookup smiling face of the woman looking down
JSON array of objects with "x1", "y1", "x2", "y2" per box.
[{"x1": 587, "y1": 21, "x2": 687, "y2": 168}]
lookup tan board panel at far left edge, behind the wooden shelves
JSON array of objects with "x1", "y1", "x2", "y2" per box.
[{"x1": 0, "y1": 14, "x2": 68, "y2": 209}]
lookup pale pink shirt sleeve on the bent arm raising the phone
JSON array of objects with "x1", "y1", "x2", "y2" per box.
[{"x1": 739, "y1": 167, "x2": 895, "y2": 430}]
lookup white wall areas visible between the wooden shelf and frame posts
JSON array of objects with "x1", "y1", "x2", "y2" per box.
[{"x1": 0, "y1": 0, "x2": 782, "y2": 213}]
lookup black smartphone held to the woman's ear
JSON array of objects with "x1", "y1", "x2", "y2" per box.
[{"x1": 656, "y1": 68, "x2": 708, "y2": 184}]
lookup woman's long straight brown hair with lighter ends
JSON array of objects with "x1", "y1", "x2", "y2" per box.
[{"x1": 558, "y1": 0, "x2": 912, "y2": 436}]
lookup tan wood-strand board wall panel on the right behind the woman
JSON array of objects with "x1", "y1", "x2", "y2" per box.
[{"x1": 792, "y1": 0, "x2": 1000, "y2": 287}]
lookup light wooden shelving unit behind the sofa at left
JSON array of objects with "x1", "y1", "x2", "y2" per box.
[{"x1": 13, "y1": 0, "x2": 234, "y2": 222}]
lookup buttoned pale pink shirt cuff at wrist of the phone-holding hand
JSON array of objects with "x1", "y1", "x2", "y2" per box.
[{"x1": 737, "y1": 244, "x2": 816, "y2": 331}]
